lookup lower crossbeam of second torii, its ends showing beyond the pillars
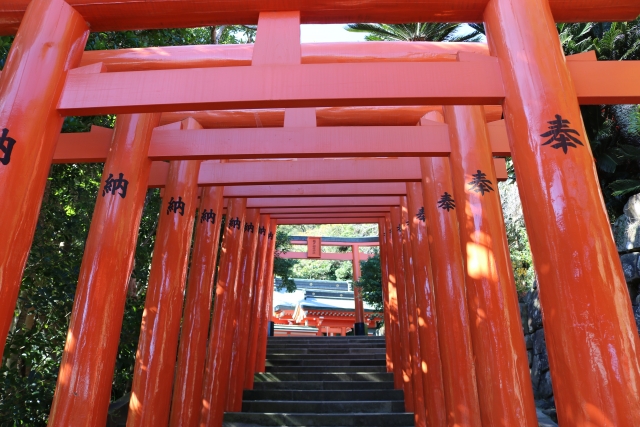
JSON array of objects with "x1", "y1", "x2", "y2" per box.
[{"x1": 53, "y1": 120, "x2": 510, "y2": 163}]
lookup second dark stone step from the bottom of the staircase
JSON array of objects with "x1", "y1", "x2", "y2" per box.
[{"x1": 242, "y1": 400, "x2": 405, "y2": 414}]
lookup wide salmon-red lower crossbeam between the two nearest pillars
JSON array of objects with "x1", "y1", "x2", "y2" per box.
[{"x1": 58, "y1": 60, "x2": 504, "y2": 115}]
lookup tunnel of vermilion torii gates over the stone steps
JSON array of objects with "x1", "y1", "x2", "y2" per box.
[{"x1": 0, "y1": 0, "x2": 640, "y2": 427}]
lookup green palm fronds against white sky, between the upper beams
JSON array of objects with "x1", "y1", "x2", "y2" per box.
[{"x1": 345, "y1": 22, "x2": 482, "y2": 42}]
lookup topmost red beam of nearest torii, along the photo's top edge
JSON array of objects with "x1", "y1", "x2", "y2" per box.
[{"x1": 0, "y1": 0, "x2": 640, "y2": 34}]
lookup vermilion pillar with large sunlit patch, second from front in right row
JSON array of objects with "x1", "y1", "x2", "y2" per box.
[{"x1": 445, "y1": 106, "x2": 538, "y2": 427}]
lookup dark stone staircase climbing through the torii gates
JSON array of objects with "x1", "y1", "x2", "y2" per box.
[{"x1": 223, "y1": 337, "x2": 414, "y2": 427}]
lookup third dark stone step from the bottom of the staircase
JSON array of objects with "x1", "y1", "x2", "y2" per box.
[{"x1": 243, "y1": 390, "x2": 404, "y2": 402}]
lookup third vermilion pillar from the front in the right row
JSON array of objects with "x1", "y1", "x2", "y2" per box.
[{"x1": 420, "y1": 150, "x2": 482, "y2": 427}]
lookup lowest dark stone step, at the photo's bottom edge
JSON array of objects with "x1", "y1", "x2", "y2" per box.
[{"x1": 222, "y1": 412, "x2": 414, "y2": 427}]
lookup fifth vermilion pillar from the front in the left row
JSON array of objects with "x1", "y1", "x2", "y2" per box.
[{"x1": 200, "y1": 198, "x2": 247, "y2": 427}]
